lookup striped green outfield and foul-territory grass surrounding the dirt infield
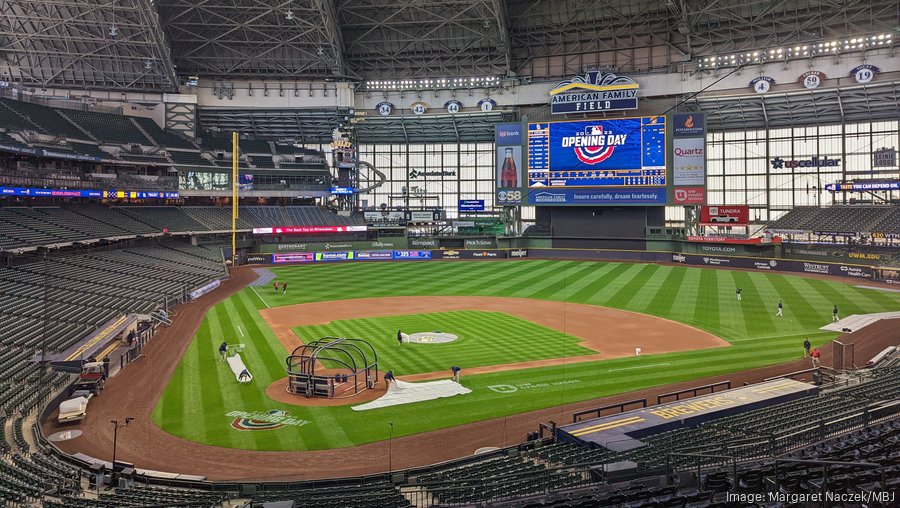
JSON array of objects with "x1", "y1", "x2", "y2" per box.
[{"x1": 153, "y1": 260, "x2": 900, "y2": 450}]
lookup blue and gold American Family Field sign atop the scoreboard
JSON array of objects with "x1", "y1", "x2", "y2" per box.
[{"x1": 550, "y1": 71, "x2": 640, "y2": 115}]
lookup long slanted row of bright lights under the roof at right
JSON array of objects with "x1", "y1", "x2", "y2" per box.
[{"x1": 697, "y1": 33, "x2": 895, "y2": 70}]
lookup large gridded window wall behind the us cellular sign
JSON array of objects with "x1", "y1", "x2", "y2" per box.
[{"x1": 704, "y1": 120, "x2": 900, "y2": 222}]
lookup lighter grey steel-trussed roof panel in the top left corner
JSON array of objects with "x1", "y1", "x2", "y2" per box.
[{"x1": 0, "y1": 0, "x2": 176, "y2": 91}]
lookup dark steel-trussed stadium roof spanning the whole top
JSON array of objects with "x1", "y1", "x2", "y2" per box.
[{"x1": 0, "y1": 0, "x2": 900, "y2": 91}]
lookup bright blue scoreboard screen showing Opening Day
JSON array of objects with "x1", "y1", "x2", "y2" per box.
[{"x1": 528, "y1": 116, "x2": 666, "y2": 190}]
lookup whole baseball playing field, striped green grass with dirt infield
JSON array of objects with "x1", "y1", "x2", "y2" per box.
[{"x1": 153, "y1": 260, "x2": 900, "y2": 450}]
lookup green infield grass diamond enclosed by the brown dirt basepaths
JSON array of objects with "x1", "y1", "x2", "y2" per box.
[{"x1": 288, "y1": 308, "x2": 596, "y2": 376}]
